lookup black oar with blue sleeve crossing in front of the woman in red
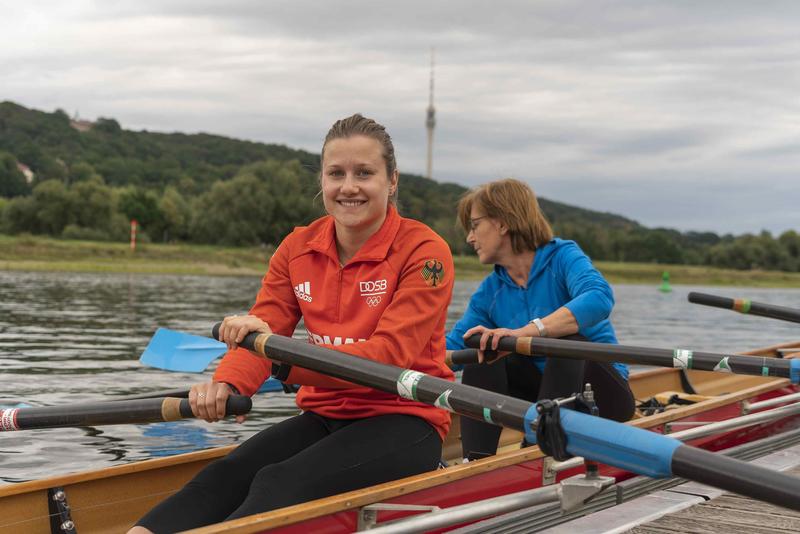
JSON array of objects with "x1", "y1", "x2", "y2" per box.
[{"x1": 214, "y1": 327, "x2": 800, "y2": 511}]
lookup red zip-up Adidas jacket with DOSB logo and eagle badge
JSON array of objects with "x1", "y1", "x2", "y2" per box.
[{"x1": 214, "y1": 205, "x2": 454, "y2": 439}]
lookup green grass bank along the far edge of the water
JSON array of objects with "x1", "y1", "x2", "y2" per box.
[{"x1": 0, "y1": 235, "x2": 800, "y2": 287}]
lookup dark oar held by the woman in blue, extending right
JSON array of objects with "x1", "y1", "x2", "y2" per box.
[{"x1": 464, "y1": 334, "x2": 800, "y2": 384}]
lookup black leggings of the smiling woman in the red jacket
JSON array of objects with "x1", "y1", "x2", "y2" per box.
[{"x1": 137, "y1": 412, "x2": 442, "y2": 532}]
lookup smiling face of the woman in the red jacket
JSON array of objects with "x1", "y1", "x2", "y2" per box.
[{"x1": 322, "y1": 135, "x2": 398, "y2": 239}]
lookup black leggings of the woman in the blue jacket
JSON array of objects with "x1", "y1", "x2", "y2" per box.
[{"x1": 461, "y1": 354, "x2": 635, "y2": 460}]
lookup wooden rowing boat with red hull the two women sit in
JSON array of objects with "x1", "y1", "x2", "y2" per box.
[{"x1": 0, "y1": 343, "x2": 800, "y2": 534}]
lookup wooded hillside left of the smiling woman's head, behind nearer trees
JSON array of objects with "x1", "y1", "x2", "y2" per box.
[{"x1": 0, "y1": 102, "x2": 319, "y2": 190}]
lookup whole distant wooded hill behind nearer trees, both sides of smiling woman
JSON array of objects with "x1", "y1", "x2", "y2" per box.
[{"x1": 0, "y1": 102, "x2": 638, "y2": 247}]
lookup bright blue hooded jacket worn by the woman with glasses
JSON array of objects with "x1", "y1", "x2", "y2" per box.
[{"x1": 447, "y1": 238, "x2": 628, "y2": 380}]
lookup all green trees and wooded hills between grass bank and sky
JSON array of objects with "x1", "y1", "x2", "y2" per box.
[{"x1": 0, "y1": 102, "x2": 800, "y2": 272}]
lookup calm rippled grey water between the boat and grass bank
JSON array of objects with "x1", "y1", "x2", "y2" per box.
[{"x1": 0, "y1": 271, "x2": 800, "y2": 484}]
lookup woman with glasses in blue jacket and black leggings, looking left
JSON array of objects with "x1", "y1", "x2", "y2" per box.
[{"x1": 447, "y1": 179, "x2": 634, "y2": 460}]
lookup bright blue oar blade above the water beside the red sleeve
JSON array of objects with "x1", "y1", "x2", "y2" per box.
[{"x1": 139, "y1": 328, "x2": 227, "y2": 373}]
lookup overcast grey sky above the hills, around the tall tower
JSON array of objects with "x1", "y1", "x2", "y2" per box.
[{"x1": 0, "y1": 0, "x2": 800, "y2": 234}]
